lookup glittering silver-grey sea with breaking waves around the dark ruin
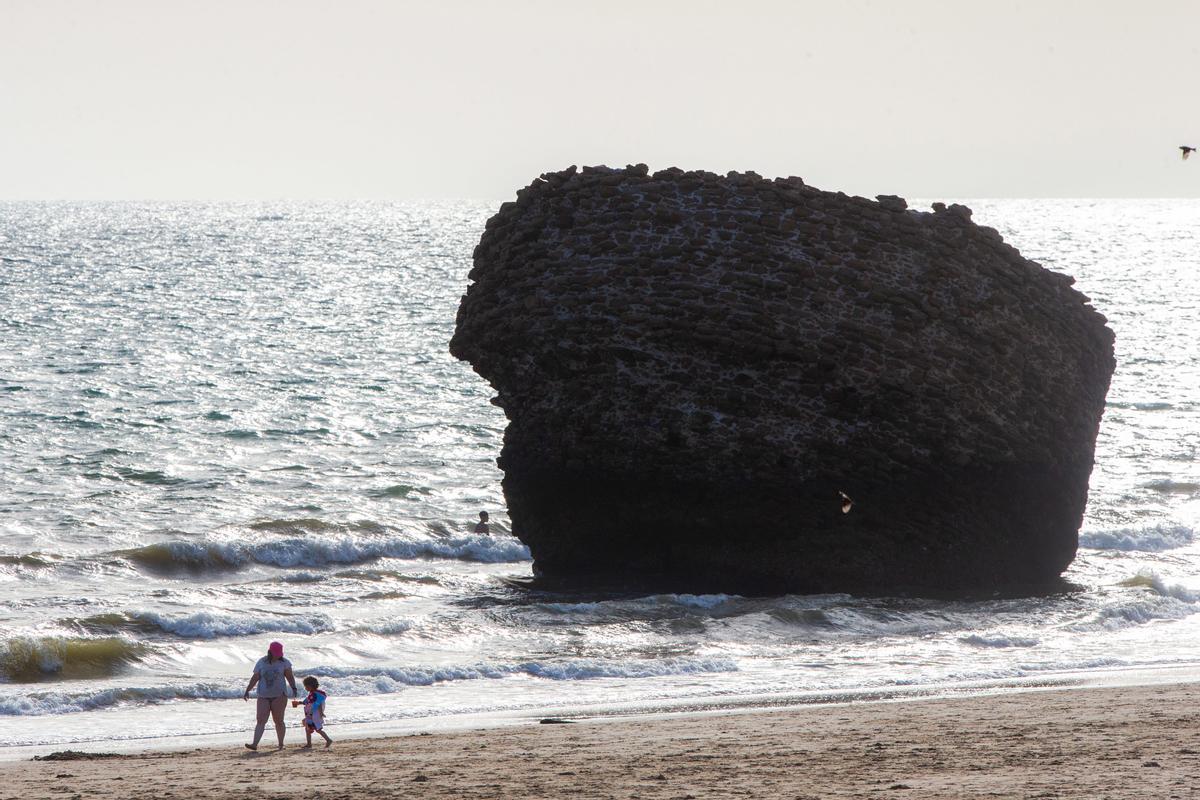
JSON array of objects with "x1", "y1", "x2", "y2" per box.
[{"x1": 0, "y1": 200, "x2": 1200, "y2": 748}]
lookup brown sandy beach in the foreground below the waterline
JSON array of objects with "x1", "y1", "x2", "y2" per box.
[{"x1": 7, "y1": 684, "x2": 1200, "y2": 800}]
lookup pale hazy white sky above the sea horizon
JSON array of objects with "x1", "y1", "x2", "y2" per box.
[{"x1": 0, "y1": 0, "x2": 1200, "y2": 199}]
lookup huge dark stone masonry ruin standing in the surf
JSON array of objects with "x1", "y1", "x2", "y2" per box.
[{"x1": 451, "y1": 164, "x2": 1114, "y2": 593}]
